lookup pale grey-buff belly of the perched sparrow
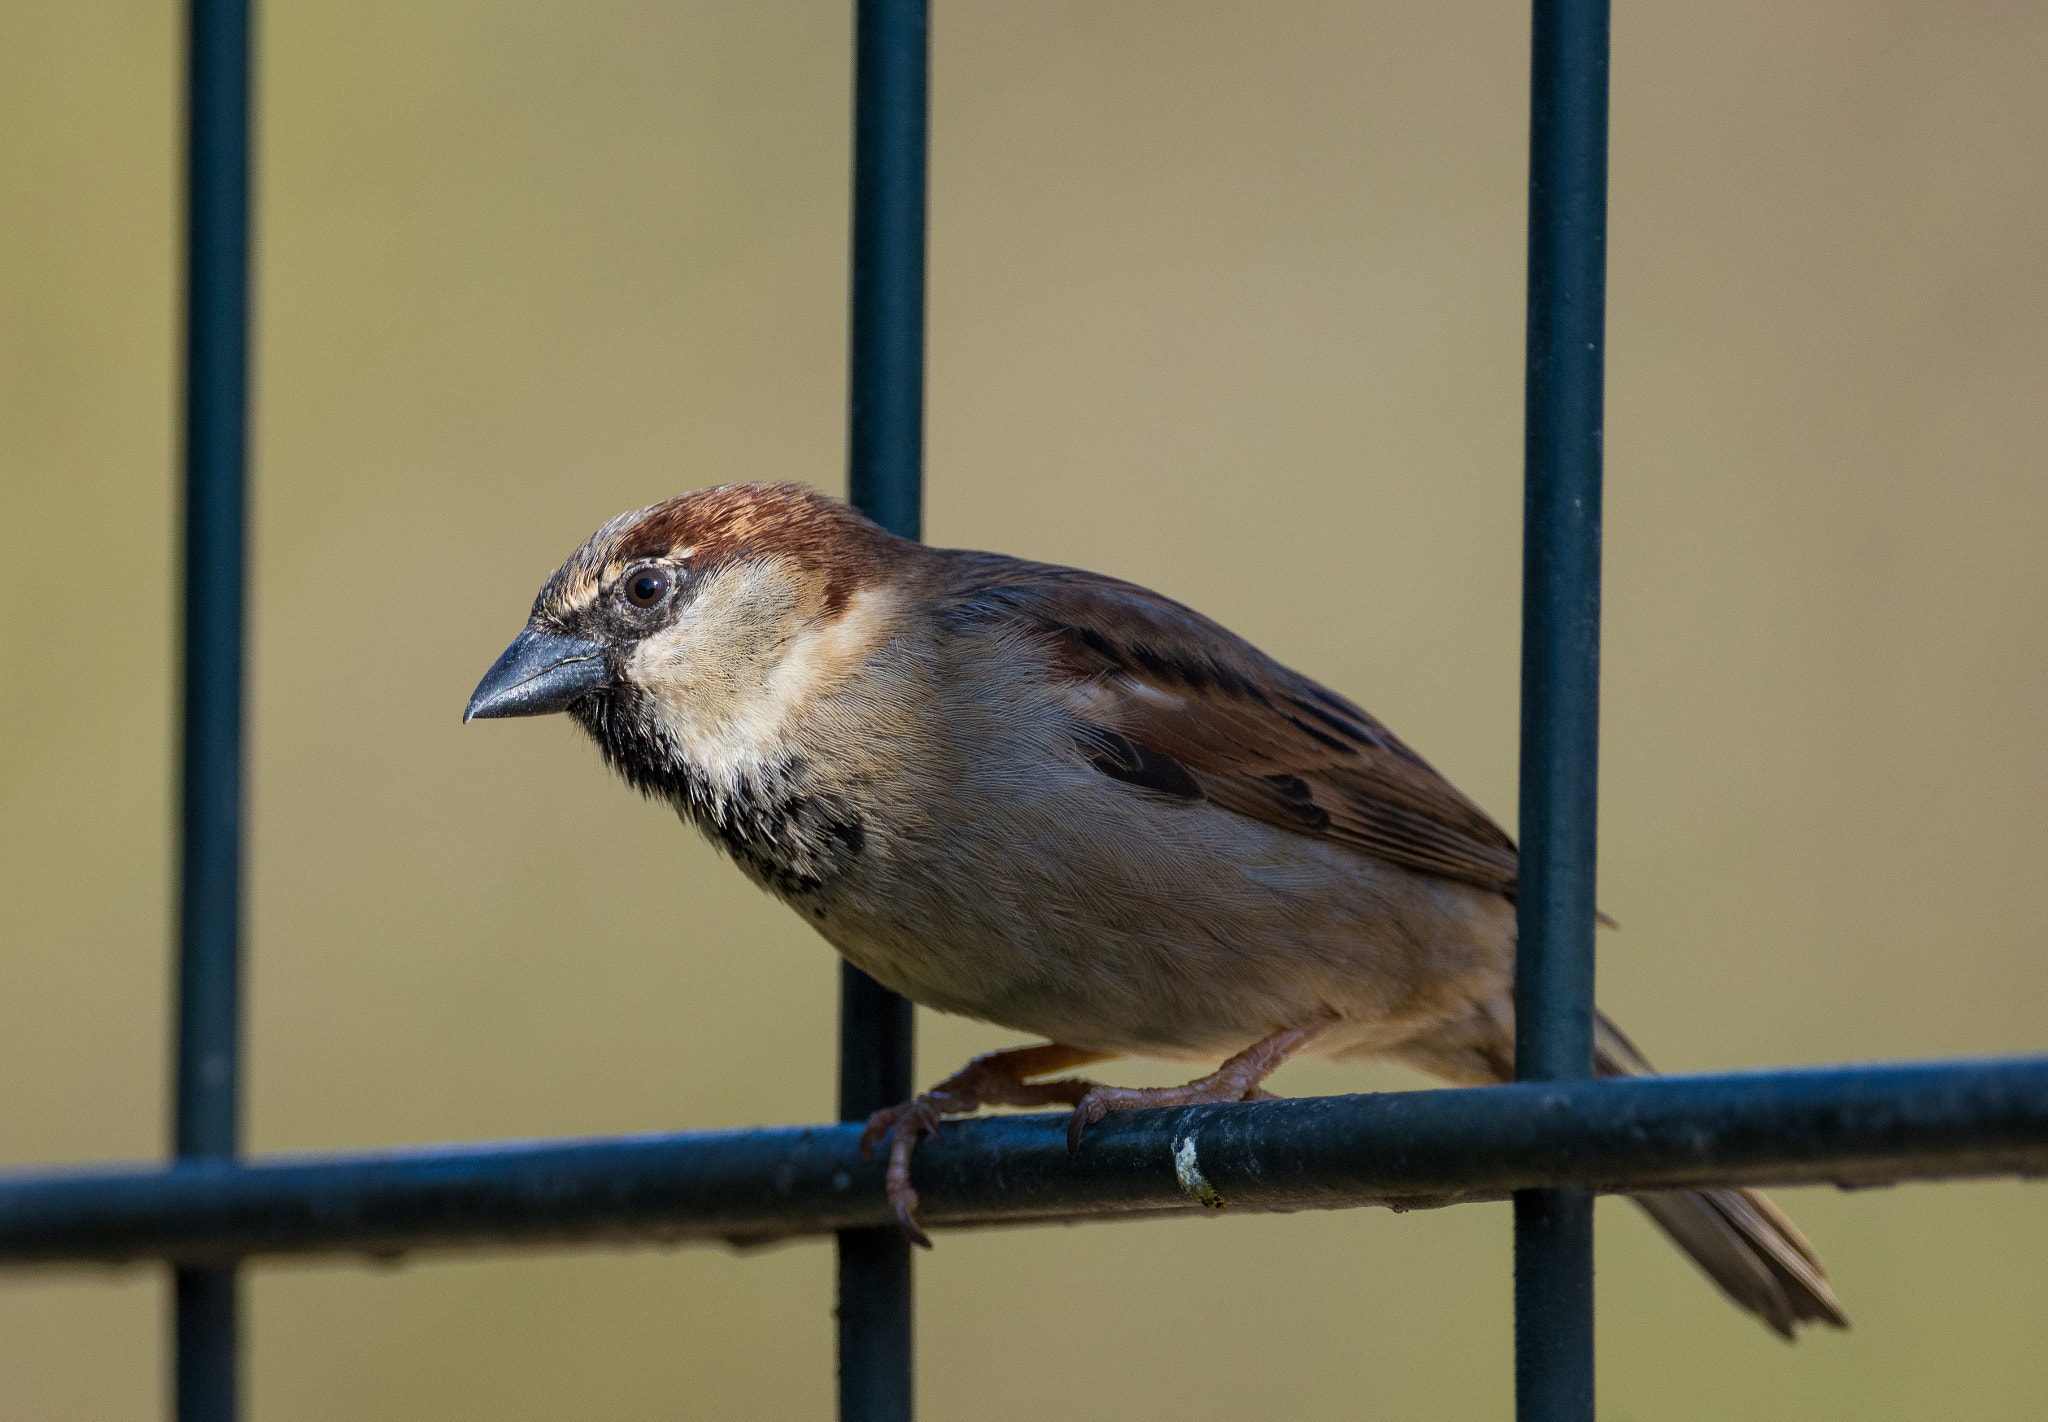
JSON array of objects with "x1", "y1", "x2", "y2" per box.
[{"x1": 815, "y1": 787, "x2": 1513, "y2": 1061}]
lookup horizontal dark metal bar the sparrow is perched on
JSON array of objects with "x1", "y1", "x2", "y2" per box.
[{"x1": 0, "y1": 1057, "x2": 2048, "y2": 1264}]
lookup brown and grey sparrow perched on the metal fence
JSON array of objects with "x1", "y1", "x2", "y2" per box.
[{"x1": 463, "y1": 484, "x2": 1849, "y2": 1338}]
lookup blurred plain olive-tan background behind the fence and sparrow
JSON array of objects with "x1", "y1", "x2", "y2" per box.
[{"x1": 0, "y1": 0, "x2": 2048, "y2": 1422}]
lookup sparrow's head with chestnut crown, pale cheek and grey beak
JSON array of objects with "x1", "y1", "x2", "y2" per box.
[{"x1": 463, "y1": 484, "x2": 918, "y2": 791}]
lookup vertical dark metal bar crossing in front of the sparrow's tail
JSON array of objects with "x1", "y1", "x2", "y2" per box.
[{"x1": 1516, "y1": 0, "x2": 1608, "y2": 1422}]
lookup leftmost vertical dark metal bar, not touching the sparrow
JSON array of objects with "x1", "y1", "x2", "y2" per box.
[{"x1": 174, "y1": 0, "x2": 250, "y2": 1422}]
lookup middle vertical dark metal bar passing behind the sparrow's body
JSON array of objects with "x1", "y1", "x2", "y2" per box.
[{"x1": 840, "y1": 0, "x2": 930, "y2": 1422}]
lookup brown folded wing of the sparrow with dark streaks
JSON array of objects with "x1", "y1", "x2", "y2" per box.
[{"x1": 954, "y1": 553, "x2": 1516, "y2": 895}]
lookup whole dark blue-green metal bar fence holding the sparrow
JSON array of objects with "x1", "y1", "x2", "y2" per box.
[{"x1": 0, "y1": 0, "x2": 2048, "y2": 1422}]
